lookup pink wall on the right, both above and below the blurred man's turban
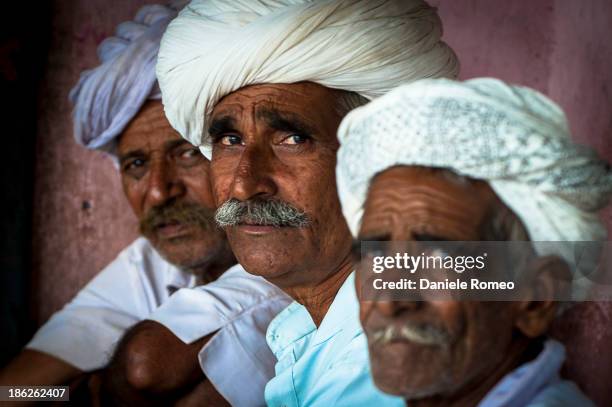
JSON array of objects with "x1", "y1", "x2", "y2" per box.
[{"x1": 431, "y1": 0, "x2": 612, "y2": 406}]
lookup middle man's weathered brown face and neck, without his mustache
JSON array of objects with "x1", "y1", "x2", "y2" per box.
[{"x1": 209, "y1": 82, "x2": 352, "y2": 325}]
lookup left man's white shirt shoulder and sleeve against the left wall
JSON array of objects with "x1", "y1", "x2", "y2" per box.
[{"x1": 26, "y1": 237, "x2": 195, "y2": 371}]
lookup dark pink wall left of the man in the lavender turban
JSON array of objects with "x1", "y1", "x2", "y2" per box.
[{"x1": 33, "y1": 0, "x2": 161, "y2": 322}]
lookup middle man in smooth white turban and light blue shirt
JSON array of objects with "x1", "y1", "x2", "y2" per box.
[{"x1": 141, "y1": 0, "x2": 458, "y2": 406}]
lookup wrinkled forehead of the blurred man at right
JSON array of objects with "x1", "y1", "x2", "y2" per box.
[{"x1": 360, "y1": 166, "x2": 499, "y2": 240}]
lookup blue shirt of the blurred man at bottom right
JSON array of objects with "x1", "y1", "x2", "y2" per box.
[{"x1": 478, "y1": 339, "x2": 595, "y2": 407}]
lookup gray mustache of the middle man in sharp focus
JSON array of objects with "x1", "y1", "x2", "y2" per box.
[{"x1": 215, "y1": 199, "x2": 310, "y2": 228}]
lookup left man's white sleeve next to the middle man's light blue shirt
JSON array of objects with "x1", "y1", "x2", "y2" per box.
[{"x1": 148, "y1": 265, "x2": 292, "y2": 406}]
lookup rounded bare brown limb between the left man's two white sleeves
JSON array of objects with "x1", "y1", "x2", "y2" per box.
[{"x1": 102, "y1": 321, "x2": 227, "y2": 406}]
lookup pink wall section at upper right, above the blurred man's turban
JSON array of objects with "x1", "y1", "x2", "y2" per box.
[{"x1": 436, "y1": 0, "x2": 612, "y2": 235}]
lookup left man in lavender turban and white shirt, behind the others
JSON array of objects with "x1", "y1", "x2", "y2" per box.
[{"x1": 1, "y1": 3, "x2": 289, "y2": 405}]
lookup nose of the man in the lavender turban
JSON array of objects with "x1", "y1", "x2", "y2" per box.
[{"x1": 146, "y1": 159, "x2": 185, "y2": 210}]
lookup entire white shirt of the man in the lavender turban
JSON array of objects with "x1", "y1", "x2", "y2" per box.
[{"x1": 26, "y1": 238, "x2": 290, "y2": 405}]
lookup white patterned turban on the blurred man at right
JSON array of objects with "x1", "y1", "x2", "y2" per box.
[{"x1": 336, "y1": 78, "x2": 612, "y2": 300}]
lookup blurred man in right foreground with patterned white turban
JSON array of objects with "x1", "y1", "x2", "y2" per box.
[{"x1": 336, "y1": 79, "x2": 612, "y2": 407}]
